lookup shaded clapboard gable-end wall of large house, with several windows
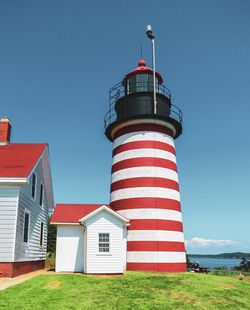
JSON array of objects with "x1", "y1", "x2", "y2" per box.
[{"x1": 15, "y1": 159, "x2": 48, "y2": 261}]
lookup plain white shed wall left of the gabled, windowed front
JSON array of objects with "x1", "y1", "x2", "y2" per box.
[{"x1": 56, "y1": 225, "x2": 84, "y2": 272}]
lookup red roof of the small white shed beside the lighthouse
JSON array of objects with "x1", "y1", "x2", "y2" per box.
[{"x1": 50, "y1": 204, "x2": 111, "y2": 223}]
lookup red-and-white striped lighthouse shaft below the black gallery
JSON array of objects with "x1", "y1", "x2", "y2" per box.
[{"x1": 110, "y1": 123, "x2": 186, "y2": 272}]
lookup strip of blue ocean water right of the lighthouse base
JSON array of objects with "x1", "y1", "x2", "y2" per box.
[{"x1": 190, "y1": 257, "x2": 241, "y2": 269}]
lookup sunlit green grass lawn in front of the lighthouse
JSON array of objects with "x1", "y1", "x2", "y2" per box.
[{"x1": 0, "y1": 272, "x2": 250, "y2": 310}]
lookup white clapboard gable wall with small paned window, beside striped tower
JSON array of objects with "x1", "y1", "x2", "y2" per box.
[{"x1": 86, "y1": 210, "x2": 124, "y2": 273}]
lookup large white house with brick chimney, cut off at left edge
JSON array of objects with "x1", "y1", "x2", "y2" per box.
[{"x1": 0, "y1": 118, "x2": 54, "y2": 277}]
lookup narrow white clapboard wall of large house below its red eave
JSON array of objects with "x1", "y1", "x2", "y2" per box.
[{"x1": 0, "y1": 186, "x2": 18, "y2": 262}]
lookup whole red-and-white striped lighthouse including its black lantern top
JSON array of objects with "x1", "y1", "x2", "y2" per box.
[{"x1": 104, "y1": 31, "x2": 186, "y2": 272}]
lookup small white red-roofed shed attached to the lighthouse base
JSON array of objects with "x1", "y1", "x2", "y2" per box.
[{"x1": 51, "y1": 204, "x2": 129, "y2": 274}]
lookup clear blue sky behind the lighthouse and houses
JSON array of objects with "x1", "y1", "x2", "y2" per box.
[{"x1": 0, "y1": 0, "x2": 250, "y2": 253}]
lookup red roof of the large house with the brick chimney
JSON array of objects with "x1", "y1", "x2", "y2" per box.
[{"x1": 0, "y1": 143, "x2": 47, "y2": 178}]
